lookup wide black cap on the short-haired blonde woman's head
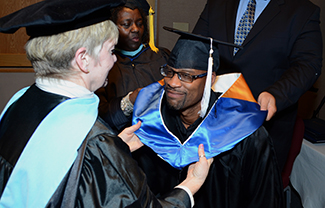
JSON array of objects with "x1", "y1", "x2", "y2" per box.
[{"x1": 0, "y1": 0, "x2": 125, "y2": 37}]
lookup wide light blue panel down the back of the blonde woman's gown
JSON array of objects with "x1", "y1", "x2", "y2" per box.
[{"x1": 0, "y1": 88, "x2": 99, "y2": 208}]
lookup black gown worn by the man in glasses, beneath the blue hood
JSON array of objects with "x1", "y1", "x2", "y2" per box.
[{"x1": 133, "y1": 94, "x2": 283, "y2": 208}]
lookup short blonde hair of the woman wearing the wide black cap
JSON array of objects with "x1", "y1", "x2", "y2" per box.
[{"x1": 25, "y1": 20, "x2": 118, "y2": 79}]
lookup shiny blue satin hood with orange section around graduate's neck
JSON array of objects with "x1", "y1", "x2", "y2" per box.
[{"x1": 132, "y1": 75, "x2": 267, "y2": 169}]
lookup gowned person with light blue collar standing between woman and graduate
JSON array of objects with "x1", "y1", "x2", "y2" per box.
[{"x1": 96, "y1": 0, "x2": 170, "y2": 131}]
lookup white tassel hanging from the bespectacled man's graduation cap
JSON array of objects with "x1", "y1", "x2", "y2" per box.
[{"x1": 199, "y1": 38, "x2": 213, "y2": 118}]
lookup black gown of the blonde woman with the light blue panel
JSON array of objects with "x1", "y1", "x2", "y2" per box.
[{"x1": 0, "y1": 85, "x2": 190, "y2": 208}]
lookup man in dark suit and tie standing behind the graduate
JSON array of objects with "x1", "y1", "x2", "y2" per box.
[{"x1": 193, "y1": 0, "x2": 322, "y2": 170}]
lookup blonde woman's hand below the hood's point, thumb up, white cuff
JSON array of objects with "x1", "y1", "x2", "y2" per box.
[{"x1": 179, "y1": 144, "x2": 213, "y2": 195}]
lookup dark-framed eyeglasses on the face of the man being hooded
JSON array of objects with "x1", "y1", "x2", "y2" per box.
[{"x1": 160, "y1": 64, "x2": 207, "y2": 83}]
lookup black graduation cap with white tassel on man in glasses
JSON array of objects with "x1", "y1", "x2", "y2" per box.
[{"x1": 163, "y1": 26, "x2": 241, "y2": 118}]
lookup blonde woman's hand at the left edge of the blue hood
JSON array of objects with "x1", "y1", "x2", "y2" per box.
[{"x1": 118, "y1": 121, "x2": 143, "y2": 152}]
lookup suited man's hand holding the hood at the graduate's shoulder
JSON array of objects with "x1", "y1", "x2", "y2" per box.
[{"x1": 257, "y1": 92, "x2": 277, "y2": 121}]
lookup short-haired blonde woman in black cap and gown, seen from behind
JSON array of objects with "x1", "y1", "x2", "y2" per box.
[{"x1": 0, "y1": 0, "x2": 209, "y2": 207}]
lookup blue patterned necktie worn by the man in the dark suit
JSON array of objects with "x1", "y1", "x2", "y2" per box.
[{"x1": 234, "y1": 0, "x2": 256, "y2": 55}]
